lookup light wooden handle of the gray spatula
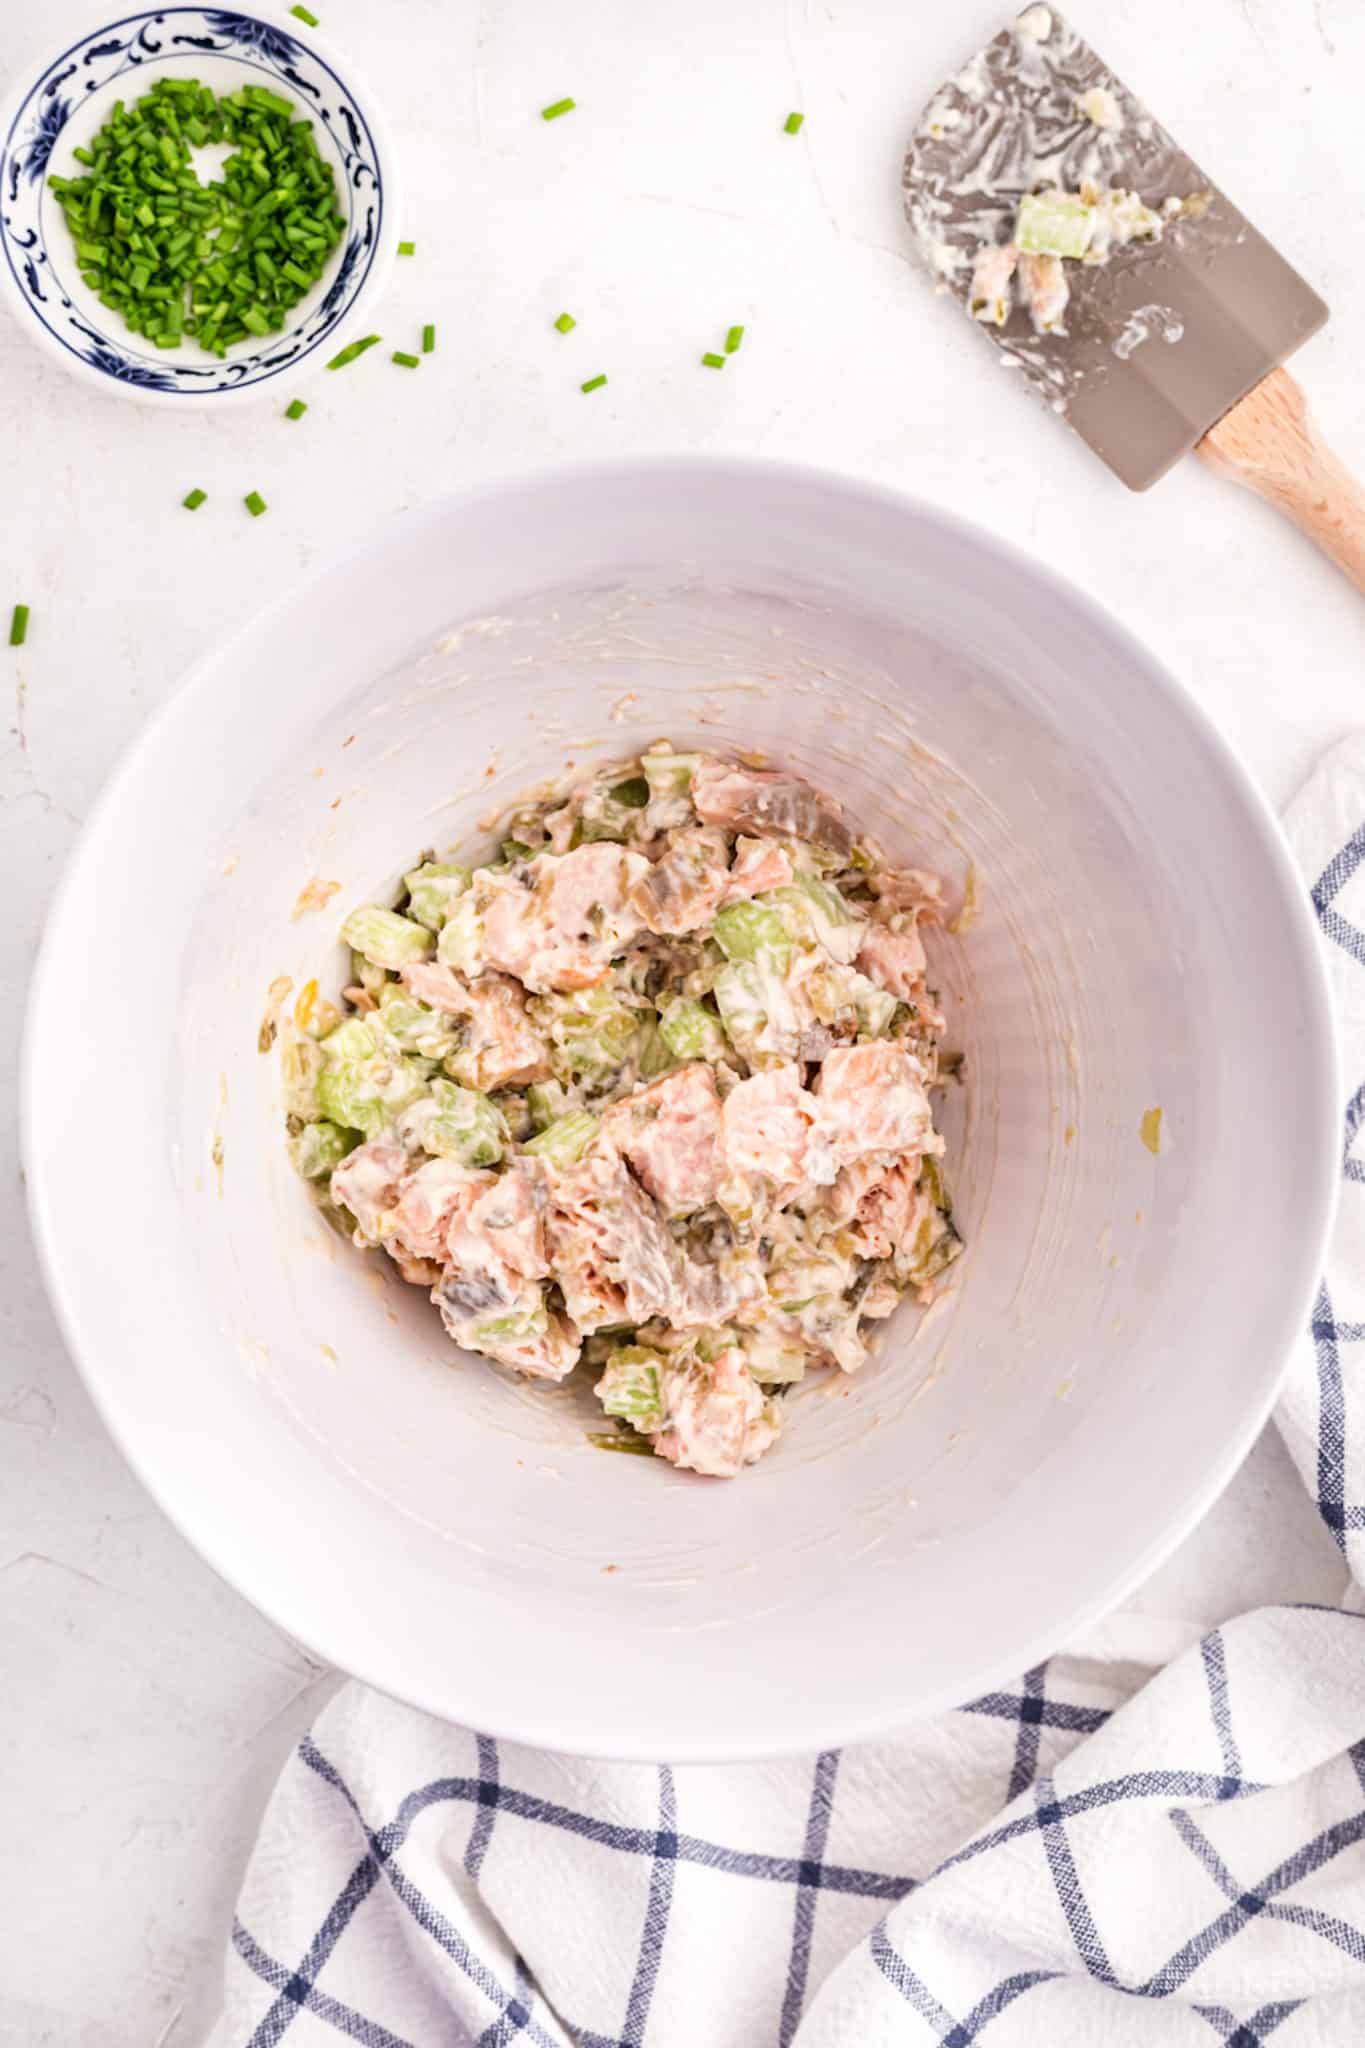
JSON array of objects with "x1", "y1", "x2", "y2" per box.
[{"x1": 1199, "y1": 371, "x2": 1365, "y2": 592}]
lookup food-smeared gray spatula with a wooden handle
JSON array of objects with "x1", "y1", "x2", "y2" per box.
[{"x1": 905, "y1": 6, "x2": 1365, "y2": 590}]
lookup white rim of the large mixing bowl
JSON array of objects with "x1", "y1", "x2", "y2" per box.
[{"x1": 18, "y1": 453, "x2": 1342, "y2": 1763}]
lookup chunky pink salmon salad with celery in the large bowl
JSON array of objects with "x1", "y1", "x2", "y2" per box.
[{"x1": 282, "y1": 743, "x2": 962, "y2": 1479}]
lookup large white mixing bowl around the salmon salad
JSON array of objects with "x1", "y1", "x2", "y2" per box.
[{"x1": 25, "y1": 459, "x2": 1336, "y2": 1759}]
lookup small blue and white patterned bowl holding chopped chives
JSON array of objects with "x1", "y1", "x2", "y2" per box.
[{"x1": 0, "y1": 6, "x2": 401, "y2": 408}]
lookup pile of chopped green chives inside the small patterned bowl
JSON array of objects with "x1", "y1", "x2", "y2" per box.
[{"x1": 47, "y1": 74, "x2": 346, "y2": 356}]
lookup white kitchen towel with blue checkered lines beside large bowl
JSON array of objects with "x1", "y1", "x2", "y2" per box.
[{"x1": 213, "y1": 737, "x2": 1365, "y2": 2048}]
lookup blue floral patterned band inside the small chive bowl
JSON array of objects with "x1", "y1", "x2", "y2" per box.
[{"x1": 0, "y1": 6, "x2": 385, "y2": 397}]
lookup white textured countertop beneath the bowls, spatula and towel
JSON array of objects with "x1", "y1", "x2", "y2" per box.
[{"x1": 0, "y1": 0, "x2": 1365, "y2": 2048}]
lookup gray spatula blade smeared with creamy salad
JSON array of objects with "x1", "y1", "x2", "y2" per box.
[{"x1": 902, "y1": 6, "x2": 1328, "y2": 492}]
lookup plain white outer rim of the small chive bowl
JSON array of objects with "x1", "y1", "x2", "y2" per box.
[{"x1": 0, "y1": 0, "x2": 403, "y2": 412}]
